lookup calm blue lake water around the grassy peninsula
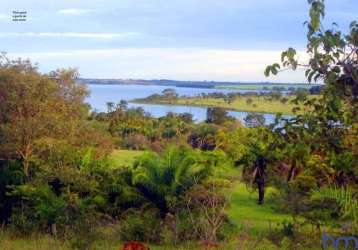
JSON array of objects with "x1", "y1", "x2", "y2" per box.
[{"x1": 87, "y1": 85, "x2": 275, "y2": 123}]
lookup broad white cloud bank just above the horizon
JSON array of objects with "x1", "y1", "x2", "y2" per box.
[{"x1": 10, "y1": 48, "x2": 306, "y2": 82}]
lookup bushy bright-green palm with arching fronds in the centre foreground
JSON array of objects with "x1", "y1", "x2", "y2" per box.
[{"x1": 132, "y1": 147, "x2": 214, "y2": 218}]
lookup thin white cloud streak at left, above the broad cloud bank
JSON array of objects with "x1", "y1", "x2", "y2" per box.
[{"x1": 0, "y1": 32, "x2": 139, "y2": 39}]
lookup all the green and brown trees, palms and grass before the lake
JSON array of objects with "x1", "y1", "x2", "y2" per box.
[{"x1": 0, "y1": 0, "x2": 358, "y2": 249}]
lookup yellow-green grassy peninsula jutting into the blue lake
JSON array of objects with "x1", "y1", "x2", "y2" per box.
[{"x1": 136, "y1": 96, "x2": 304, "y2": 115}]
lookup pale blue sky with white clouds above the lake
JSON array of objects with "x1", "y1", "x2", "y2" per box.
[{"x1": 0, "y1": 0, "x2": 358, "y2": 82}]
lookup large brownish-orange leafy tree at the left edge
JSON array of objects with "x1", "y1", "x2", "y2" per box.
[{"x1": 0, "y1": 55, "x2": 88, "y2": 176}]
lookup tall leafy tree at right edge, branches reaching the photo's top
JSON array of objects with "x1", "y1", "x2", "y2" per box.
[{"x1": 265, "y1": 0, "x2": 358, "y2": 227}]
